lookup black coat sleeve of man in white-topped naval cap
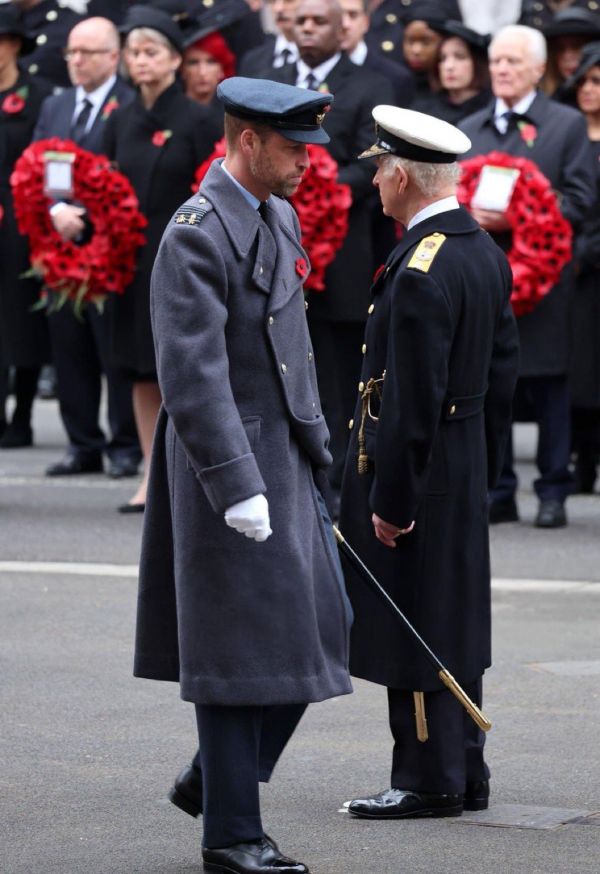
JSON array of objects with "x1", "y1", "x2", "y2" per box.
[{"x1": 370, "y1": 269, "x2": 454, "y2": 528}]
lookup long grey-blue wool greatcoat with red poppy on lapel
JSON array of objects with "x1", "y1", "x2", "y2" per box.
[{"x1": 134, "y1": 161, "x2": 352, "y2": 705}]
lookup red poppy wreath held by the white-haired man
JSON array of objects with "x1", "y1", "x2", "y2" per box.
[{"x1": 458, "y1": 152, "x2": 573, "y2": 316}]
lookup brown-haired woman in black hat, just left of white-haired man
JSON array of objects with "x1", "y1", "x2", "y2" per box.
[{"x1": 411, "y1": 21, "x2": 492, "y2": 124}]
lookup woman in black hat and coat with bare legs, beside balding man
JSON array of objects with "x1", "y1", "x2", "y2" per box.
[{"x1": 104, "y1": 6, "x2": 219, "y2": 512}]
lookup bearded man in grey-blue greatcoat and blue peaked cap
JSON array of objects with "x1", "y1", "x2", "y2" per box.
[{"x1": 135, "y1": 77, "x2": 352, "y2": 874}]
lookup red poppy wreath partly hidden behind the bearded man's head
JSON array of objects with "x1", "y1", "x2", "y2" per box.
[{"x1": 192, "y1": 140, "x2": 352, "y2": 291}]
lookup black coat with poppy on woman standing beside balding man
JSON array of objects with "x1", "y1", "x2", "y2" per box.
[{"x1": 103, "y1": 83, "x2": 221, "y2": 378}]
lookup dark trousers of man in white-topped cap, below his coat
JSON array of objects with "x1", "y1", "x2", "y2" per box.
[{"x1": 388, "y1": 678, "x2": 490, "y2": 795}]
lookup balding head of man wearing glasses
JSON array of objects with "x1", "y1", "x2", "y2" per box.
[{"x1": 66, "y1": 17, "x2": 120, "y2": 92}]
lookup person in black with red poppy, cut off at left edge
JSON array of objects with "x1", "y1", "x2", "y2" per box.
[{"x1": 0, "y1": 4, "x2": 50, "y2": 449}]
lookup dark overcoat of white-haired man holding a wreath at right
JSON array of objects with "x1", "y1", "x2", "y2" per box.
[{"x1": 459, "y1": 94, "x2": 596, "y2": 376}]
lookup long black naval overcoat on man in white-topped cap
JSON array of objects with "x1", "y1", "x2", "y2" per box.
[{"x1": 340, "y1": 209, "x2": 518, "y2": 691}]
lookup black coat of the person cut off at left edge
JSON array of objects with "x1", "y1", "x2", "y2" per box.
[{"x1": 0, "y1": 73, "x2": 50, "y2": 367}]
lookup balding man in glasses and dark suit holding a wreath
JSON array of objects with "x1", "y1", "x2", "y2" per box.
[{"x1": 33, "y1": 18, "x2": 140, "y2": 477}]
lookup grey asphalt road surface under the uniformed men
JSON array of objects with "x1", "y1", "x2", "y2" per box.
[{"x1": 0, "y1": 402, "x2": 600, "y2": 874}]
